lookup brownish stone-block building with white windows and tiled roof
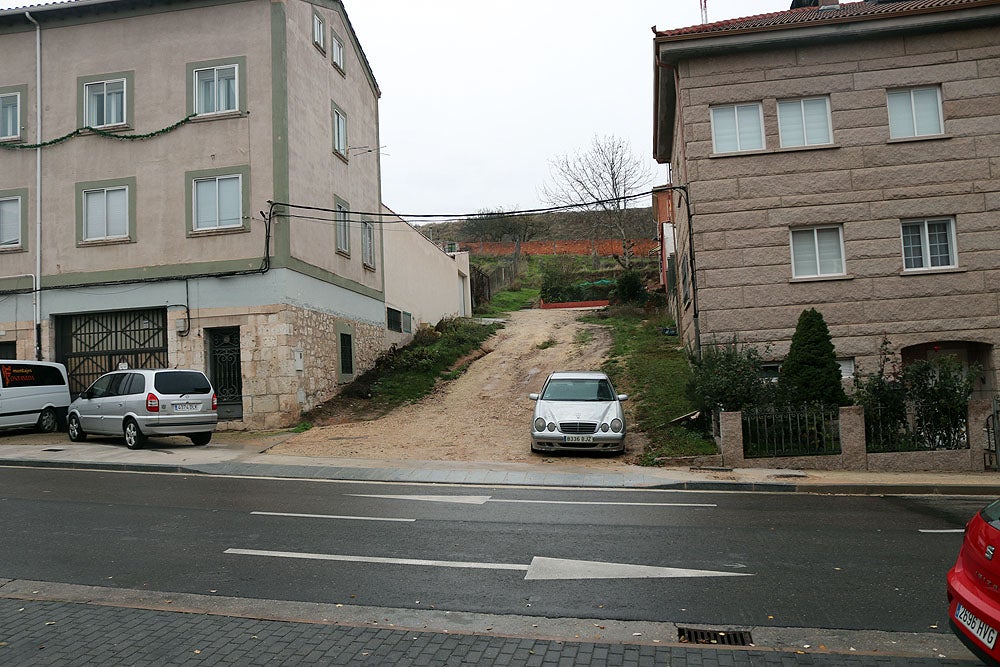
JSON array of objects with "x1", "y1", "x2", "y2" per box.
[{"x1": 654, "y1": 0, "x2": 1000, "y2": 397}]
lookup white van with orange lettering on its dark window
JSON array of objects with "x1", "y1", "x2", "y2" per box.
[{"x1": 0, "y1": 359, "x2": 70, "y2": 433}]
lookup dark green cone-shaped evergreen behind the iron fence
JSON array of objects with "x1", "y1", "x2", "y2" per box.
[{"x1": 778, "y1": 308, "x2": 849, "y2": 406}]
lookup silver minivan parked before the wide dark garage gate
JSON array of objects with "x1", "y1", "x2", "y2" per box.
[{"x1": 67, "y1": 368, "x2": 219, "y2": 449}]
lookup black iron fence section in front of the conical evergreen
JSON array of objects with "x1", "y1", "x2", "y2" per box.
[{"x1": 743, "y1": 405, "x2": 840, "y2": 459}]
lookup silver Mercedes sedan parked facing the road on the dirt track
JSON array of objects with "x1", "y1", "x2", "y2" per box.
[{"x1": 529, "y1": 371, "x2": 628, "y2": 453}]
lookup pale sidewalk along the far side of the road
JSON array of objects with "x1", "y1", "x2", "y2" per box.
[{"x1": 0, "y1": 431, "x2": 1000, "y2": 496}]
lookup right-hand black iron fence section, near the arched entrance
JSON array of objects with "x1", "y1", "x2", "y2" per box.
[{"x1": 865, "y1": 402, "x2": 969, "y2": 453}]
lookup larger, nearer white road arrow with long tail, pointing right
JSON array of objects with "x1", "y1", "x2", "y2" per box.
[{"x1": 225, "y1": 549, "x2": 753, "y2": 580}]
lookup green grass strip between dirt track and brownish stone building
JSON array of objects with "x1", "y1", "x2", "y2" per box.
[{"x1": 582, "y1": 308, "x2": 718, "y2": 465}]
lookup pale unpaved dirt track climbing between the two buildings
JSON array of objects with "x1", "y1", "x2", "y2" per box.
[{"x1": 269, "y1": 310, "x2": 644, "y2": 467}]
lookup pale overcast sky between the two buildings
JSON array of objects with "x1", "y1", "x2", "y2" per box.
[{"x1": 0, "y1": 0, "x2": 791, "y2": 215}]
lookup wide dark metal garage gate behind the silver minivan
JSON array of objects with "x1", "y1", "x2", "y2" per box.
[{"x1": 56, "y1": 308, "x2": 168, "y2": 395}]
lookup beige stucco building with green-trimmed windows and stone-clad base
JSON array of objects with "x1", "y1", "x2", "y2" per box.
[{"x1": 0, "y1": 0, "x2": 459, "y2": 427}]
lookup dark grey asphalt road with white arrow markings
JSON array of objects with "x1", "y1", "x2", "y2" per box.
[{"x1": 0, "y1": 469, "x2": 983, "y2": 633}]
